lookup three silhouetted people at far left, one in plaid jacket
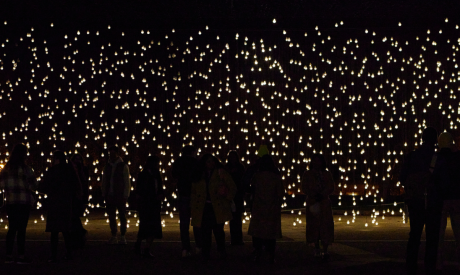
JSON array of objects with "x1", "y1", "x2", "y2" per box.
[{"x1": 0, "y1": 144, "x2": 88, "y2": 264}]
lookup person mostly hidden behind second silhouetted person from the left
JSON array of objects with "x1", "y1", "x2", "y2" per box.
[{"x1": 70, "y1": 154, "x2": 89, "y2": 248}]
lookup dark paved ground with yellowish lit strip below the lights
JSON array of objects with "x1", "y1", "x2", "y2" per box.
[{"x1": 0, "y1": 211, "x2": 460, "y2": 275}]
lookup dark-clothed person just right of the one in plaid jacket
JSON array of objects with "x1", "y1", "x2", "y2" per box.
[{"x1": 39, "y1": 151, "x2": 81, "y2": 263}]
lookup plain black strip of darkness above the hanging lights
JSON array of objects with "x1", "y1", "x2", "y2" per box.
[{"x1": 0, "y1": 0, "x2": 460, "y2": 28}]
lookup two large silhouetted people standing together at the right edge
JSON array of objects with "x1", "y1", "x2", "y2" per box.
[{"x1": 400, "y1": 127, "x2": 460, "y2": 274}]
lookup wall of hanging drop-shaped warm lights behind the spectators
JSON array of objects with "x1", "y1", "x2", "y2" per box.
[{"x1": 0, "y1": 19, "x2": 460, "y2": 230}]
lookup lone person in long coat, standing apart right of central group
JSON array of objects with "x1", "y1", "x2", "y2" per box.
[{"x1": 302, "y1": 154, "x2": 334, "y2": 260}]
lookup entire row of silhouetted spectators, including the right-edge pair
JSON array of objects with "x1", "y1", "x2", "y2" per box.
[{"x1": 0, "y1": 127, "x2": 460, "y2": 274}]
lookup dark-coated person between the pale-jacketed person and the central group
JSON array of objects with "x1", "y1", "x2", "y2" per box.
[{"x1": 135, "y1": 156, "x2": 164, "y2": 257}]
